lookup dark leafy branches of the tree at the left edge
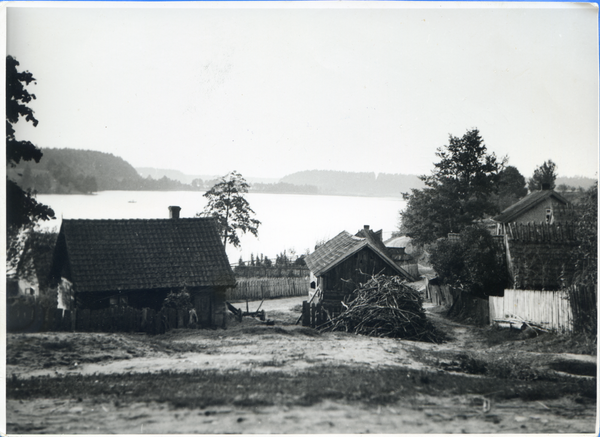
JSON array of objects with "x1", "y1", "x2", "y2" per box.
[{"x1": 6, "y1": 56, "x2": 54, "y2": 235}]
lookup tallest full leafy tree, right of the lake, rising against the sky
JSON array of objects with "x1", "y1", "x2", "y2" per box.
[{"x1": 400, "y1": 129, "x2": 506, "y2": 244}]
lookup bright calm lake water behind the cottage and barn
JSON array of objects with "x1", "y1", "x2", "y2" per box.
[{"x1": 37, "y1": 191, "x2": 406, "y2": 264}]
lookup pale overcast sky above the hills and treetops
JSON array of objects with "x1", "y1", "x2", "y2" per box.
[{"x1": 7, "y1": 2, "x2": 598, "y2": 178}]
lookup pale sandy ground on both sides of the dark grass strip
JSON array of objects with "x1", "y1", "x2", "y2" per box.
[{"x1": 6, "y1": 292, "x2": 597, "y2": 434}]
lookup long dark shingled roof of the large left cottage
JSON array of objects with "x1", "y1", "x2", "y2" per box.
[{"x1": 54, "y1": 218, "x2": 236, "y2": 292}]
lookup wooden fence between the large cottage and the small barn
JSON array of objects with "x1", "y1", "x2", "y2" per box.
[{"x1": 226, "y1": 278, "x2": 309, "y2": 301}]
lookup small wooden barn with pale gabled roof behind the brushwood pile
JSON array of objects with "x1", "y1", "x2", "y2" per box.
[{"x1": 306, "y1": 226, "x2": 415, "y2": 310}]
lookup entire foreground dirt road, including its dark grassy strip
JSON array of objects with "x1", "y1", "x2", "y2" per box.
[{"x1": 6, "y1": 298, "x2": 596, "y2": 434}]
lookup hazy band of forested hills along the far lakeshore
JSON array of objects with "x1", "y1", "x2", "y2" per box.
[{"x1": 7, "y1": 149, "x2": 594, "y2": 197}]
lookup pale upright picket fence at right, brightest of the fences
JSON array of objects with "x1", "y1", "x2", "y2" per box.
[{"x1": 489, "y1": 290, "x2": 573, "y2": 332}]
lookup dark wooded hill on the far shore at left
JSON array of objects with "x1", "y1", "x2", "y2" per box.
[{"x1": 7, "y1": 148, "x2": 193, "y2": 194}]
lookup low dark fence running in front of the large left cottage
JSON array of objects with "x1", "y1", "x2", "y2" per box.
[{"x1": 6, "y1": 305, "x2": 196, "y2": 334}]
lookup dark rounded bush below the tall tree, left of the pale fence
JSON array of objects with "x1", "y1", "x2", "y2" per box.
[{"x1": 429, "y1": 226, "x2": 510, "y2": 296}]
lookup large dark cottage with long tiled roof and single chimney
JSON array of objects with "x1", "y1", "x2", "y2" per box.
[{"x1": 52, "y1": 207, "x2": 236, "y2": 326}]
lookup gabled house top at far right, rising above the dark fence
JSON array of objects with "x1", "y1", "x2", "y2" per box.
[{"x1": 493, "y1": 189, "x2": 571, "y2": 234}]
